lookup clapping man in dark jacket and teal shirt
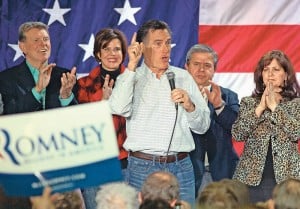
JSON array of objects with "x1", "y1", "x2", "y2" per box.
[{"x1": 0, "y1": 22, "x2": 77, "y2": 114}]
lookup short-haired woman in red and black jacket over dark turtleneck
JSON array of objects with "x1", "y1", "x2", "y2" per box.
[{"x1": 77, "y1": 28, "x2": 127, "y2": 209}]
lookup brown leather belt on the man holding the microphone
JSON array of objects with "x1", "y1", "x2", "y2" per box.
[{"x1": 129, "y1": 152, "x2": 188, "y2": 163}]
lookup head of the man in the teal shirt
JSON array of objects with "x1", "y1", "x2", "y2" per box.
[{"x1": 19, "y1": 22, "x2": 51, "y2": 69}]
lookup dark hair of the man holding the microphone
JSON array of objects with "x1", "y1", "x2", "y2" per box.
[{"x1": 136, "y1": 20, "x2": 172, "y2": 42}]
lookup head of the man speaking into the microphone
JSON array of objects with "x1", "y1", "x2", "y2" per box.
[{"x1": 136, "y1": 20, "x2": 172, "y2": 73}]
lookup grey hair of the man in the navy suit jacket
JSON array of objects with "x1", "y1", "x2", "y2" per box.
[{"x1": 185, "y1": 44, "x2": 218, "y2": 70}]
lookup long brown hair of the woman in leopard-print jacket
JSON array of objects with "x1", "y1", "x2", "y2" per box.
[{"x1": 252, "y1": 50, "x2": 300, "y2": 99}]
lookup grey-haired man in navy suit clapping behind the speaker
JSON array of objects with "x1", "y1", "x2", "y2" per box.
[{"x1": 185, "y1": 44, "x2": 239, "y2": 195}]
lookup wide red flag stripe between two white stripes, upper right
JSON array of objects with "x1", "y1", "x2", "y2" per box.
[{"x1": 199, "y1": 25, "x2": 300, "y2": 72}]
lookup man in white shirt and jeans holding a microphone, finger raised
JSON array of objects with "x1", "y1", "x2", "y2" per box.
[{"x1": 109, "y1": 20, "x2": 210, "y2": 205}]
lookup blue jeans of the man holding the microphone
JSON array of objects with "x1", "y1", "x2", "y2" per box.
[{"x1": 126, "y1": 155, "x2": 195, "y2": 206}]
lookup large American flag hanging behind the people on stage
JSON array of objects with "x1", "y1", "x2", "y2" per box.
[{"x1": 0, "y1": 0, "x2": 300, "y2": 100}]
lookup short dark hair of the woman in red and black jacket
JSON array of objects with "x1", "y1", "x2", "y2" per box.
[{"x1": 93, "y1": 28, "x2": 127, "y2": 62}]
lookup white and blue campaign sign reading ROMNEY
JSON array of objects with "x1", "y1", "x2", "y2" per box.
[{"x1": 0, "y1": 102, "x2": 122, "y2": 196}]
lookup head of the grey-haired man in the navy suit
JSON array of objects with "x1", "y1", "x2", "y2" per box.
[{"x1": 185, "y1": 44, "x2": 218, "y2": 87}]
